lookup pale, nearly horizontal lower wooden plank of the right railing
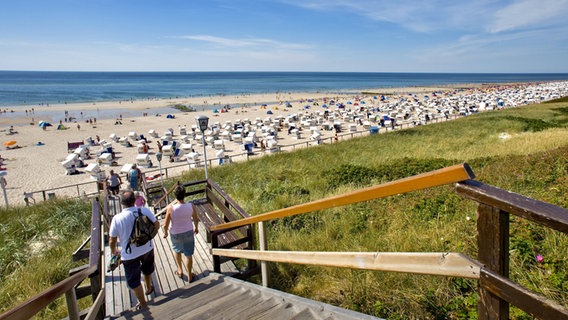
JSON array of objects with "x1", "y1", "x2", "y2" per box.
[{"x1": 211, "y1": 249, "x2": 481, "y2": 279}]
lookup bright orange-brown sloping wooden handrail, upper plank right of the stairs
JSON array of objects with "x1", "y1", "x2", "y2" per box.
[{"x1": 211, "y1": 163, "x2": 474, "y2": 231}]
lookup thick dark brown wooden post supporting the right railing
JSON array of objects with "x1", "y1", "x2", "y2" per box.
[{"x1": 477, "y1": 203, "x2": 509, "y2": 320}]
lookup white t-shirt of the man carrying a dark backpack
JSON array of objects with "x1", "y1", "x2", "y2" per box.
[{"x1": 108, "y1": 207, "x2": 156, "y2": 260}]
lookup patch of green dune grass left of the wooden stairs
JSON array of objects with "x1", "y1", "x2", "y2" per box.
[{"x1": 0, "y1": 200, "x2": 91, "y2": 319}]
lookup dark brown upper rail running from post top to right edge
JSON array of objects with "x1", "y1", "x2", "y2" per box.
[{"x1": 456, "y1": 180, "x2": 568, "y2": 233}]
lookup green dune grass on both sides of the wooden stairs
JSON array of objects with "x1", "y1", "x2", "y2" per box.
[{"x1": 0, "y1": 101, "x2": 568, "y2": 319}]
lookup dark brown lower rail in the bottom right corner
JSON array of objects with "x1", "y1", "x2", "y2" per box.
[{"x1": 479, "y1": 268, "x2": 568, "y2": 319}]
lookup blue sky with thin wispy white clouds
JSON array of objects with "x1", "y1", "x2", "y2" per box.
[{"x1": 0, "y1": 0, "x2": 568, "y2": 73}]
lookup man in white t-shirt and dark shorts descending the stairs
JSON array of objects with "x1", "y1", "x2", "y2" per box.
[{"x1": 109, "y1": 191, "x2": 160, "y2": 309}]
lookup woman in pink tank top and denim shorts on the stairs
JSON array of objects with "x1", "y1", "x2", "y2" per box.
[{"x1": 164, "y1": 186, "x2": 199, "y2": 282}]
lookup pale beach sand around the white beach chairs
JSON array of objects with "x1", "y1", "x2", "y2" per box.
[{"x1": 0, "y1": 85, "x2": 560, "y2": 205}]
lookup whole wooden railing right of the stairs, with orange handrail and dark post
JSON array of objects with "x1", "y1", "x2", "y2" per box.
[{"x1": 211, "y1": 164, "x2": 568, "y2": 320}]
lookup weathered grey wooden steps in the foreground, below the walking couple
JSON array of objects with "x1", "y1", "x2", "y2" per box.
[{"x1": 117, "y1": 273, "x2": 379, "y2": 320}]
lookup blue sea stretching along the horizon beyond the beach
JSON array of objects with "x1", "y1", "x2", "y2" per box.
[{"x1": 0, "y1": 71, "x2": 568, "y2": 118}]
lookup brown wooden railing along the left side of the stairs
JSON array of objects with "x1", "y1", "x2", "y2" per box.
[{"x1": 0, "y1": 200, "x2": 105, "y2": 320}]
